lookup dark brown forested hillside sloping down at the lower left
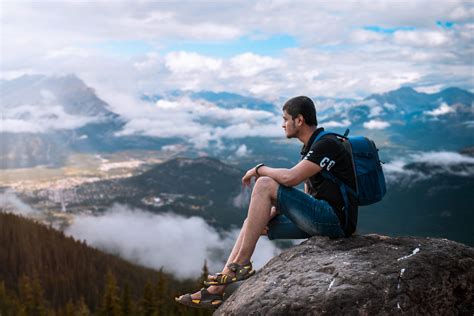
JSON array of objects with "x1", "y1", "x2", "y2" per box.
[{"x1": 0, "y1": 212, "x2": 211, "y2": 315}]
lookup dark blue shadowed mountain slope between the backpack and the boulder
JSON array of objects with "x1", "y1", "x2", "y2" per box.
[{"x1": 358, "y1": 148, "x2": 474, "y2": 246}]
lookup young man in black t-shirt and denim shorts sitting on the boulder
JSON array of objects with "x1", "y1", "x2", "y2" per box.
[{"x1": 176, "y1": 96, "x2": 358, "y2": 308}]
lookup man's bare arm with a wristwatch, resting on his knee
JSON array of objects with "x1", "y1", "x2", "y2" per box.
[{"x1": 242, "y1": 160, "x2": 321, "y2": 187}]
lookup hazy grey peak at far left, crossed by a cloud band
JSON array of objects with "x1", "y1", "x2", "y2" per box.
[{"x1": 0, "y1": 75, "x2": 173, "y2": 169}]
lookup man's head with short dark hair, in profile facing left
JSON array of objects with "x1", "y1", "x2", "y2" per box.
[{"x1": 282, "y1": 96, "x2": 318, "y2": 138}]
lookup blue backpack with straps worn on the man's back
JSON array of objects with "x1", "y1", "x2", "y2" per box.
[{"x1": 314, "y1": 129, "x2": 387, "y2": 227}]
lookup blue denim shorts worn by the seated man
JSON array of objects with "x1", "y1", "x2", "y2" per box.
[{"x1": 268, "y1": 185, "x2": 344, "y2": 239}]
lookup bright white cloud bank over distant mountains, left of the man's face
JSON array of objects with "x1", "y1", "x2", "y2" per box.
[{"x1": 110, "y1": 94, "x2": 283, "y2": 149}]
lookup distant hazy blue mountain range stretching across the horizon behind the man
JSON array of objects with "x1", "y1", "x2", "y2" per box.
[{"x1": 0, "y1": 75, "x2": 474, "y2": 169}]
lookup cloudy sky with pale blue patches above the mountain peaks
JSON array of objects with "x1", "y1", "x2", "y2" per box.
[{"x1": 0, "y1": 0, "x2": 474, "y2": 101}]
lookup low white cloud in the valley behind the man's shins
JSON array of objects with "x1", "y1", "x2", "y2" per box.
[{"x1": 66, "y1": 205, "x2": 279, "y2": 278}]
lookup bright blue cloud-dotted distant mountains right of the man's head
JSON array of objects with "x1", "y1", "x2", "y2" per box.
[{"x1": 320, "y1": 87, "x2": 474, "y2": 156}]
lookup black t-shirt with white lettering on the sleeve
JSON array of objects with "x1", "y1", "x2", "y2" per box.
[{"x1": 301, "y1": 128, "x2": 358, "y2": 236}]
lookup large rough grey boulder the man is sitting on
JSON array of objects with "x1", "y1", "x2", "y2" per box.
[{"x1": 214, "y1": 235, "x2": 474, "y2": 315}]
